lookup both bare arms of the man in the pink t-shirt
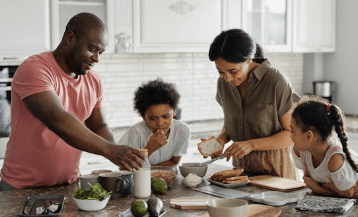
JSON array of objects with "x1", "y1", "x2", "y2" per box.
[{"x1": 23, "y1": 91, "x2": 144, "y2": 170}]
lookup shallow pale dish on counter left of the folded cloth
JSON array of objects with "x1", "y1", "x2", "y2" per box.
[{"x1": 250, "y1": 191, "x2": 298, "y2": 206}]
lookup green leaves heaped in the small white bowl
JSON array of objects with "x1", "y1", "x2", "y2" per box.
[{"x1": 72, "y1": 183, "x2": 112, "y2": 201}]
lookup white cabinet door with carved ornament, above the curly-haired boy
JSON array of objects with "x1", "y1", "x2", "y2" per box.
[{"x1": 133, "y1": 0, "x2": 239, "y2": 52}]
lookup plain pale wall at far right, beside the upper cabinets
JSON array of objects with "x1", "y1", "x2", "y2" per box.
[{"x1": 304, "y1": 0, "x2": 358, "y2": 115}]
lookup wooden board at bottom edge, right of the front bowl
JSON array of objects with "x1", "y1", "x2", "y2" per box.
[{"x1": 201, "y1": 204, "x2": 281, "y2": 217}]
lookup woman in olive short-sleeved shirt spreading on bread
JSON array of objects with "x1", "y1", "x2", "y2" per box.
[{"x1": 209, "y1": 29, "x2": 300, "y2": 179}]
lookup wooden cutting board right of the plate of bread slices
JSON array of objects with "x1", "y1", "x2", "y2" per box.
[{"x1": 249, "y1": 175, "x2": 306, "y2": 192}]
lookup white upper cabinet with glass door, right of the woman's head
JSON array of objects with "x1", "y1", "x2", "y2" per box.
[{"x1": 242, "y1": 0, "x2": 336, "y2": 53}]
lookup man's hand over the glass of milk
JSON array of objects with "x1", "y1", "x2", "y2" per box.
[{"x1": 106, "y1": 145, "x2": 145, "y2": 171}]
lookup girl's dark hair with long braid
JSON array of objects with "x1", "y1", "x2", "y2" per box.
[{"x1": 292, "y1": 96, "x2": 358, "y2": 172}]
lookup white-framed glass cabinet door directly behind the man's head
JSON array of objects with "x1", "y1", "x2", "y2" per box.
[{"x1": 51, "y1": 0, "x2": 114, "y2": 53}]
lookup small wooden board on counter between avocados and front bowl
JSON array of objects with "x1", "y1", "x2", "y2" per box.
[{"x1": 169, "y1": 197, "x2": 212, "y2": 210}]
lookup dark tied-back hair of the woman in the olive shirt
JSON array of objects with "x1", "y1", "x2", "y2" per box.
[{"x1": 209, "y1": 29, "x2": 264, "y2": 63}]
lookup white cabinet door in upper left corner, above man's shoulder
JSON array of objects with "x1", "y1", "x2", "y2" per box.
[{"x1": 0, "y1": 0, "x2": 51, "y2": 62}]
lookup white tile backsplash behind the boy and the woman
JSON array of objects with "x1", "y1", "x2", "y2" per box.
[{"x1": 94, "y1": 53, "x2": 303, "y2": 128}]
